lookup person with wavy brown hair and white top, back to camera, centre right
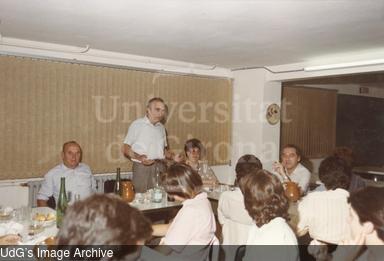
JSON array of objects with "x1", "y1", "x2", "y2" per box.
[{"x1": 240, "y1": 170, "x2": 298, "y2": 260}]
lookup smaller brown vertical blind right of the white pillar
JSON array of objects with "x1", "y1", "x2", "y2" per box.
[{"x1": 281, "y1": 86, "x2": 337, "y2": 158}]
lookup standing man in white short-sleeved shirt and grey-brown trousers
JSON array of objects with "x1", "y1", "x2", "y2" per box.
[{"x1": 123, "y1": 97, "x2": 171, "y2": 193}]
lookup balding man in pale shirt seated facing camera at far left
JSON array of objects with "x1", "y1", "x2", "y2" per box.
[{"x1": 37, "y1": 141, "x2": 95, "y2": 207}]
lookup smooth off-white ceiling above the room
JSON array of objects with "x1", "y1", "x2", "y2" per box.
[{"x1": 0, "y1": 0, "x2": 384, "y2": 69}]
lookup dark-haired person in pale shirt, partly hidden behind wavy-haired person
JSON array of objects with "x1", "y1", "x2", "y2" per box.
[{"x1": 217, "y1": 154, "x2": 263, "y2": 245}]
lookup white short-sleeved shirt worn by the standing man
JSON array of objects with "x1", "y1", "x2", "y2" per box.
[{"x1": 124, "y1": 117, "x2": 167, "y2": 159}]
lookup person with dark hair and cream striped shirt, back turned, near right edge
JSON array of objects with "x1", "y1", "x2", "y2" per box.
[{"x1": 297, "y1": 156, "x2": 350, "y2": 244}]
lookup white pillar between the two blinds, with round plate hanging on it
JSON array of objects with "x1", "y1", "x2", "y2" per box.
[{"x1": 231, "y1": 69, "x2": 281, "y2": 179}]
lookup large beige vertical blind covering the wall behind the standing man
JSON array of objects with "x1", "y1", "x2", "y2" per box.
[{"x1": 0, "y1": 56, "x2": 232, "y2": 179}]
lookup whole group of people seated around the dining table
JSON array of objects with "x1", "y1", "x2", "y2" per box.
[{"x1": 0, "y1": 139, "x2": 384, "y2": 260}]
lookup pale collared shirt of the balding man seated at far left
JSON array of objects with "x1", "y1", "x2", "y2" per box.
[{"x1": 37, "y1": 163, "x2": 95, "y2": 203}]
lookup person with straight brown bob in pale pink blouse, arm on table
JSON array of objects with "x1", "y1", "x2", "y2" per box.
[{"x1": 153, "y1": 163, "x2": 218, "y2": 260}]
